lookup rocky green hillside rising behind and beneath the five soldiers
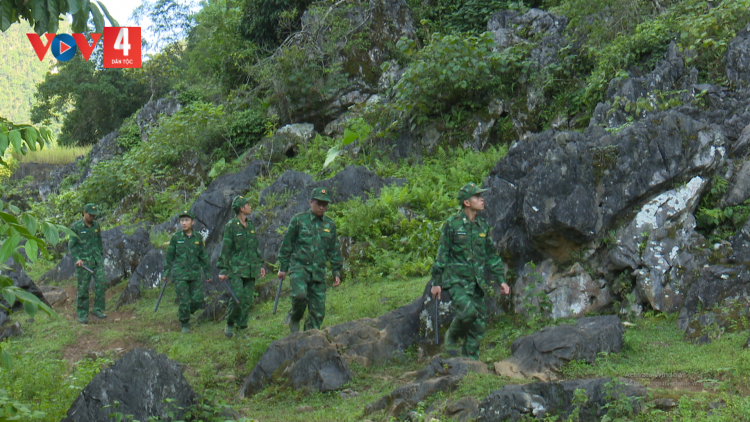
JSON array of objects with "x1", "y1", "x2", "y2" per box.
[{"x1": 0, "y1": 0, "x2": 750, "y2": 421}]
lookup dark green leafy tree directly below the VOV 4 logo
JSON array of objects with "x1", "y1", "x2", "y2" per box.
[{"x1": 31, "y1": 54, "x2": 148, "y2": 145}]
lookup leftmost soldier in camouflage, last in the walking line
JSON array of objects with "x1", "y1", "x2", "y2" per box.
[{"x1": 68, "y1": 204, "x2": 107, "y2": 324}]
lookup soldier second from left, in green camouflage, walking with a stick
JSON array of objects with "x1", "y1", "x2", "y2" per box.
[{"x1": 164, "y1": 211, "x2": 211, "y2": 334}]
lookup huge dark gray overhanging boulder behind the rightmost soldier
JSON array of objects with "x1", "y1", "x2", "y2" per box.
[{"x1": 484, "y1": 109, "x2": 724, "y2": 266}]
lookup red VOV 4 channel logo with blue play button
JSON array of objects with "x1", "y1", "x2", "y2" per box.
[{"x1": 26, "y1": 26, "x2": 141, "y2": 68}]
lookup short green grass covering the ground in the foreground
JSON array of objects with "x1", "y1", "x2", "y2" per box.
[{"x1": 0, "y1": 268, "x2": 750, "y2": 421}]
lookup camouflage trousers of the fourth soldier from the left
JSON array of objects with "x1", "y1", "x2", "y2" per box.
[{"x1": 289, "y1": 269, "x2": 326, "y2": 331}]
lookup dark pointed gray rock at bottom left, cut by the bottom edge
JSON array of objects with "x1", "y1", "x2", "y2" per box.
[{"x1": 63, "y1": 348, "x2": 198, "y2": 422}]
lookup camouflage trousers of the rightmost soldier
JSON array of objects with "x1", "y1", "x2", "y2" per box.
[{"x1": 446, "y1": 283, "x2": 487, "y2": 360}]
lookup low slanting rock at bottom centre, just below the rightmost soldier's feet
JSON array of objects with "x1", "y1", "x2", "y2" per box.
[{"x1": 364, "y1": 358, "x2": 489, "y2": 419}]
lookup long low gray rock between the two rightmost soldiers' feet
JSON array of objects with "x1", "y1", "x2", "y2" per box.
[{"x1": 240, "y1": 298, "x2": 422, "y2": 397}]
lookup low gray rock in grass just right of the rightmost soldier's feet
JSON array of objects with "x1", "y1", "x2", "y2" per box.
[{"x1": 495, "y1": 315, "x2": 625, "y2": 381}]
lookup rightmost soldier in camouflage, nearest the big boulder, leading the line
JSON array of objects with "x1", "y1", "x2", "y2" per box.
[{"x1": 431, "y1": 183, "x2": 510, "y2": 359}]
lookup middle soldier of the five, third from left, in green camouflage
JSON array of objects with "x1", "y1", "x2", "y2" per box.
[{"x1": 217, "y1": 196, "x2": 266, "y2": 337}]
